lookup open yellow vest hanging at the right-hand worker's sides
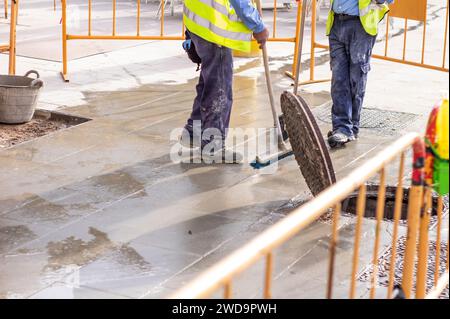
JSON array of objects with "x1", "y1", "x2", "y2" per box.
[{"x1": 327, "y1": 0, "x2": 389, "y2": 36}]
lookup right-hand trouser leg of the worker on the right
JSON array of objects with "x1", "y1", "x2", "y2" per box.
[{"x1": 350, "y1": 20, "x2": 376, "y2": 136}]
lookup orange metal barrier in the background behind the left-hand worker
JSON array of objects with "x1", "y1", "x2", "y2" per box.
[{"x1": 61, "y1": 0, "x2": 302, "y2": 82}]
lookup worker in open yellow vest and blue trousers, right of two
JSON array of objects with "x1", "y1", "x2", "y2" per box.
[{"x1": 326, "y1": 0, "x2": 394, "y2": 147}]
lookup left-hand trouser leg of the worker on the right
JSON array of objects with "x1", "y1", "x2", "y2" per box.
[{"x1": 329, "y1": 19, "x2": 353, "y2": 137}]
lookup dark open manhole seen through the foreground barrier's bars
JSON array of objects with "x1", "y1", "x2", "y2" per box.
[{"x1": 342, "y1": 185, "x2": 448, "y2": 221}]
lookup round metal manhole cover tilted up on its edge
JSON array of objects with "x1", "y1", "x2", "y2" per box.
[{"x1": 281, "y1": 92, "x2": 336, "y2": 196}]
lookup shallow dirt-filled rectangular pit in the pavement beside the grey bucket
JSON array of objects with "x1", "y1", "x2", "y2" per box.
[{"x1": 0, "y1": 110, "x2": 90, "y2": 150}]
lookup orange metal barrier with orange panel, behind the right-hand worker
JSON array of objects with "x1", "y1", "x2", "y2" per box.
[{"x1": 301, "y1": 0, "x2": 449, "y2": 84}]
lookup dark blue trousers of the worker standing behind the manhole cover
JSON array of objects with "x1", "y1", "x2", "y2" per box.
[{"x1": 329, "y1": 15, "x2": 376, "y2": 136}]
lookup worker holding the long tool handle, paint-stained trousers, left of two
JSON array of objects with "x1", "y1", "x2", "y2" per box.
[{"x1": 181, "y1": 0, "x2": 269, "y2": 163}]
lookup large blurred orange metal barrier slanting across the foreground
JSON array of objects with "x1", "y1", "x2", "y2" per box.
[{"x1": 170, "y1": 133, "x2": 449, "y2": 299}]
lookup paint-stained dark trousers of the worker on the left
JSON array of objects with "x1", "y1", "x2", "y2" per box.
[{"x1": 185, "y1": 32, "x2": 233, "y2": 146}]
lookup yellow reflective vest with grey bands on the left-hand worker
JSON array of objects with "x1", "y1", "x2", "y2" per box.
[{"x1": 184, "y1": 0, "x2": 253, "y2": 52}]
